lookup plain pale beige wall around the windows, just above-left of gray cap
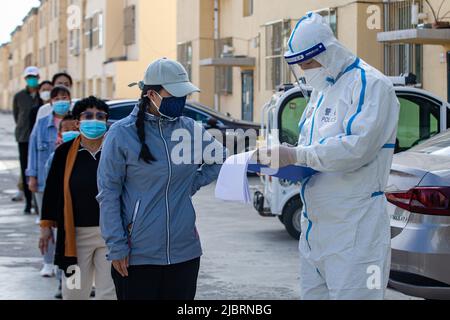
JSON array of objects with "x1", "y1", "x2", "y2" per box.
[{"x1": 68, "y1": 0, "x2": 176, "y2": 99}]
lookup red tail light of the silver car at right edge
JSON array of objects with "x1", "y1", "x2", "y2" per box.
[{"x1": 386, "y1": 187, "x2": 450, "y2": 216}]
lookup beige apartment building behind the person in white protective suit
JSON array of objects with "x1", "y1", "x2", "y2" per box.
[{"x1": 177, "y1": 0, "x2": 450, "y2": 121}]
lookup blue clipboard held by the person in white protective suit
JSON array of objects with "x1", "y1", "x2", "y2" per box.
[{"x1": 247, "y1": 164, "x2": 318, "y2": 182}]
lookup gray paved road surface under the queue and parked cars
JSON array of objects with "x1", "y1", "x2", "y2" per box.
[{"x1": 0, "y1": 114, "x2": 418, "y2": 300}]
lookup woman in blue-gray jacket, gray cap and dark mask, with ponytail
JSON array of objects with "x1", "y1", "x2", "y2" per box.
[{"x1": 97, "y1": 59, "x2": 227, "y2": 300}]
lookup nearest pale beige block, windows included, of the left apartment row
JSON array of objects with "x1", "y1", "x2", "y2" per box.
[{"x1": 68, "y1": 0, "x2": 176, "y2": 99}]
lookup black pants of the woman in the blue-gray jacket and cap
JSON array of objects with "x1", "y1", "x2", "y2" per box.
[{"x1": 112, "y1": 258, "x2": 200, "y2": 301}]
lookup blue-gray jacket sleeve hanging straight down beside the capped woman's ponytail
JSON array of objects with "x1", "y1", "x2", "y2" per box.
[{"x1": 97, "y1": 126, "x2": 130, "y2": 261}]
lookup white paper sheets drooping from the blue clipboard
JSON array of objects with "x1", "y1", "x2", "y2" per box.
[{"x1": 216, "y1": 151, "x2": 256, "y2": 203}]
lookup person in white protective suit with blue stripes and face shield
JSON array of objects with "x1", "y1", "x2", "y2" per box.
[{"x1": 260, "y1": 13, "x2": 399, "y2": 300}]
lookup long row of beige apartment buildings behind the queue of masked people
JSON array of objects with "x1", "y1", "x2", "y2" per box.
[{"x1": 0, "y1": 0, "x2": 177, "y2": 109}]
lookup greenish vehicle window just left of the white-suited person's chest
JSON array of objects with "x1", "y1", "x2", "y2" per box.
[{"x1": 279, "y1": 95, "x2": 307, "y2": 145}]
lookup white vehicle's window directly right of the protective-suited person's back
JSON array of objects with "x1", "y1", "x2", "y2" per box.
[{"x1": 396, "y1": 95, "x2": 440, "y2": 152}]
